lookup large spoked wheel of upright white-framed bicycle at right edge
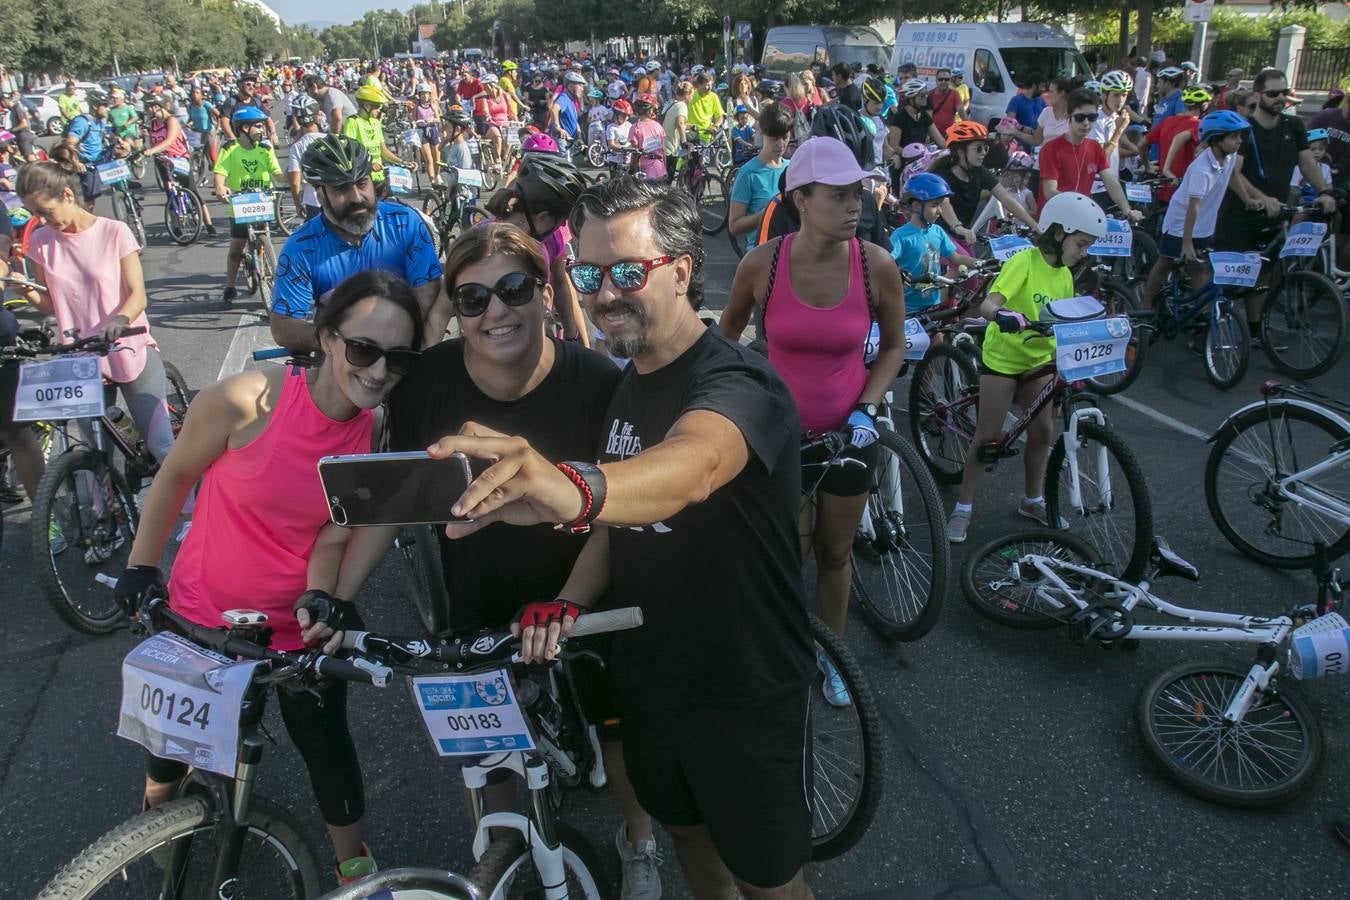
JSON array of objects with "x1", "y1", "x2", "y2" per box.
[{"x1": 1204, "y1": 402, "x2": 1350, "y2": 568}]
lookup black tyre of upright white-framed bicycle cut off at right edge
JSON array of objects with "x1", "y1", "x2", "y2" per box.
[{"x1": 1204, "y1": 401, "x2": 1350, "y2": 569}]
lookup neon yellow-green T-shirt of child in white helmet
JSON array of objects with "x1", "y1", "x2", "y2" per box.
[{"x1": 981, "y1": 247, "x2": 1073, "y2": 375}]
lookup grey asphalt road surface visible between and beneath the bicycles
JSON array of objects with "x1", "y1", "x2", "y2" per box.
[{"x1": 0, "y1": 149, "x2": 1350, "y2": 897}]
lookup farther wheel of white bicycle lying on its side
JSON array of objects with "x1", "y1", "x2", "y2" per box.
[{"x1": 961, "y1": 528, "x2": 1096, "y2": 630}]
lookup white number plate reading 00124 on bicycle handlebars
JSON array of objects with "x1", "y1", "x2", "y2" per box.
[{"x1": 117, "y1": 631, "x2": 258, "y2": 777}]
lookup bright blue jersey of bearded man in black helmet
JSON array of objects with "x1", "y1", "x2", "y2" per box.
[{"x1": 271, "y1": 202, "x2": 441, "y2": 318}]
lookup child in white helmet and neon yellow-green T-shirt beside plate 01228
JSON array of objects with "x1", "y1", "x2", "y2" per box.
[{"x1": 946, "y1": 192, "x2": 1106, "y2": 544}]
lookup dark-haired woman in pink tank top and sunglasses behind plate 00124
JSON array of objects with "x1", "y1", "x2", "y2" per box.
[{"x1": 117, "y1": 270, "x2": 423, "y2": 877}]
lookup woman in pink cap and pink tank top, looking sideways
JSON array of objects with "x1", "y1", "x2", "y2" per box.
[{"x1": 722, "y1": 138, "x2": 905, "y2": 666}]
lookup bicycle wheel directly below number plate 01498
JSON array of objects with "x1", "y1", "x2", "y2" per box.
[{"x1": 1261, "y1": 270, "x2": 1346, "y2": 378}]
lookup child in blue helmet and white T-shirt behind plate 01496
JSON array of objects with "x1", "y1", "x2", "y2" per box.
[{"x1": 1143, "y1": 109, "x2": 1251, "y2": 314}]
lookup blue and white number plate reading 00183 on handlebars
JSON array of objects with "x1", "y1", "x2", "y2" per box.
[{"x1": 410, "y1": 669, "x2": 535, "y2": 756}]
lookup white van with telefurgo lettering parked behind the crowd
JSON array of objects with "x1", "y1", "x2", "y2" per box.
[{"x1": 890, "y1": 22, "x2": 1092, "y2": 125}]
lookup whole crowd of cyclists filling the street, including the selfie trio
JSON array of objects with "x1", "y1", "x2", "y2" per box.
[{"x1": 0, "y1": 31, "x2": 1350, "y2": 897}]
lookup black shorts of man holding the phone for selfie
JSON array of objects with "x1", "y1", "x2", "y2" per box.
[{"x1": 624, "y1": 687, "x2": 813, "y2": 888}]
